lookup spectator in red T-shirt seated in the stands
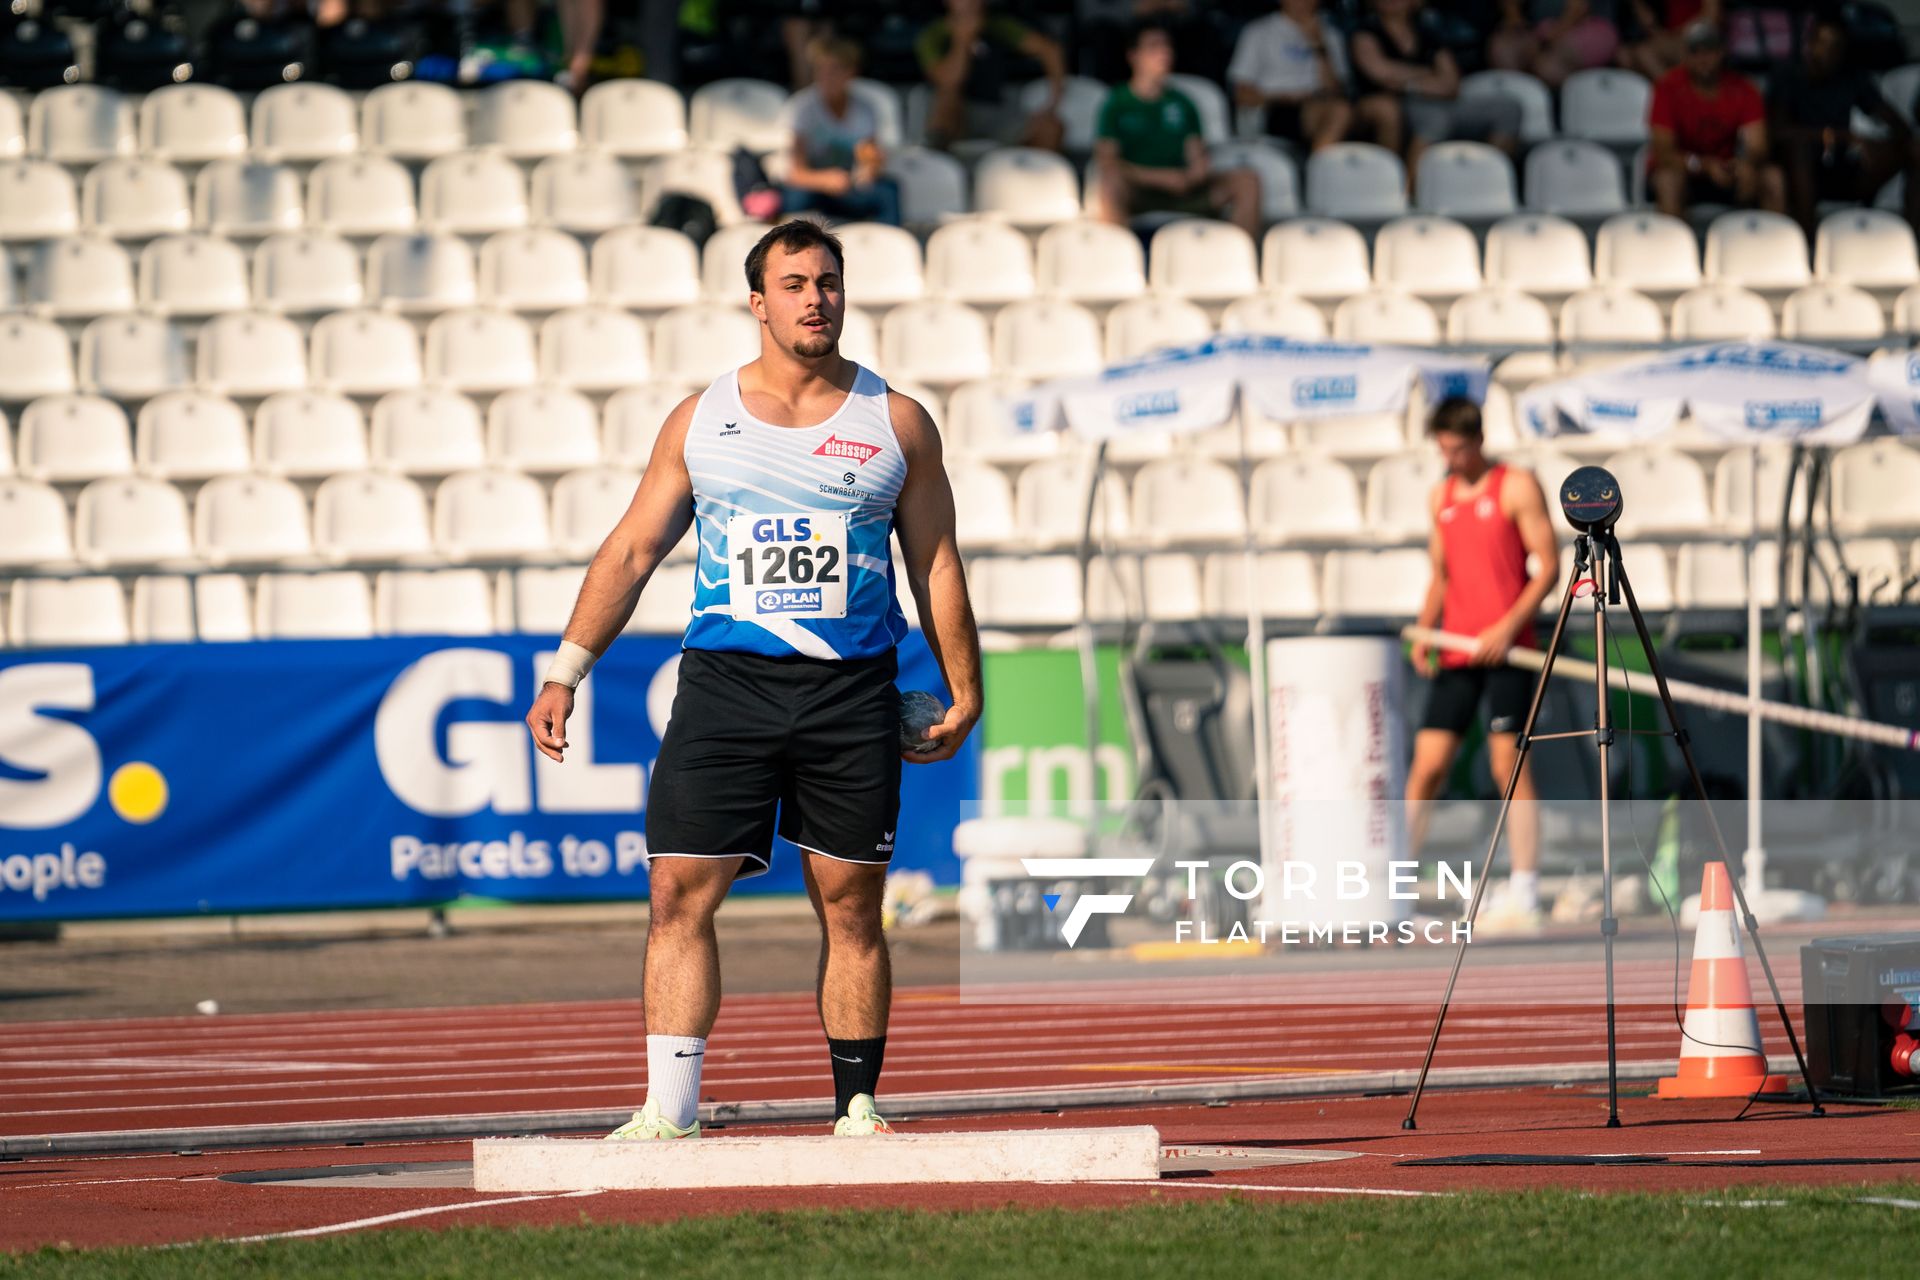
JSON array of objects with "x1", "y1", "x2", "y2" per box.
[{"x1": 1647, "y1": 23, "x2": 1786, "y2": 217}]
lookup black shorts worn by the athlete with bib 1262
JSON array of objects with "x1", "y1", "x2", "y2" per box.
[{"x1": 647, "y1": 649, "x2": 900, "y2": 877}]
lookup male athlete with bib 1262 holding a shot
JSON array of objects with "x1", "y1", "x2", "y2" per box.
[{"x1": 526, "y1": 221, "x2": 981, "y2": 1138}]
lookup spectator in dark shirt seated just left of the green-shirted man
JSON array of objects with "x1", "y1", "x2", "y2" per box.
[{"x1": 914, "y1": 0, "x2": 1068, "y2": 152}]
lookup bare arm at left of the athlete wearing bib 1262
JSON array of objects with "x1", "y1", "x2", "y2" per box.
[{"x1": 526, "y1": 395, "x2": 699, "y2": 760}]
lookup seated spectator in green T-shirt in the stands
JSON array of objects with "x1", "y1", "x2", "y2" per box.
[{"x1": 1094, "y1": 21, "x2": 1260, "y2": 236}]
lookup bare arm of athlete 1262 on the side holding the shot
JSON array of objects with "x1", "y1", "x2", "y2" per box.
[{"x1": 889, "y1": 391, "x2": 981, "y2": 764}]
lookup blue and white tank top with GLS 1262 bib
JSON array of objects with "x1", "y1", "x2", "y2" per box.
[{"x1": 682, "y1": 365, "x2": 906, "y2": 658}]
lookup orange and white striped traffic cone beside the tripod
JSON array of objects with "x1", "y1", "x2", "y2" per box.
[{"x1": 1659, "y1": 862, "x2": 1788, "y2": 1098}]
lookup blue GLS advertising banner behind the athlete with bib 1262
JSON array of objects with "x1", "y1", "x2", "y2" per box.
[{"x1": 0, "y1": 631, "x2": 979, "y2": 919}]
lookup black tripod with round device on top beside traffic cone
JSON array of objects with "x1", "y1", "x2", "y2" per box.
[{"x1": 1400, "y1": 495, "x2": 1822, "y2": 1128}]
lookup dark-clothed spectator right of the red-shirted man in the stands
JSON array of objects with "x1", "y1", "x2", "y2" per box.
[{"x1": 1766, "y1": 13, "x2": 1920, "y2": 232}]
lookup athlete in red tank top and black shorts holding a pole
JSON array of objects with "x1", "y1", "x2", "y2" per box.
[{"x1": 1407, "y1": 397, "x2": 1559, "y2": 931}]
